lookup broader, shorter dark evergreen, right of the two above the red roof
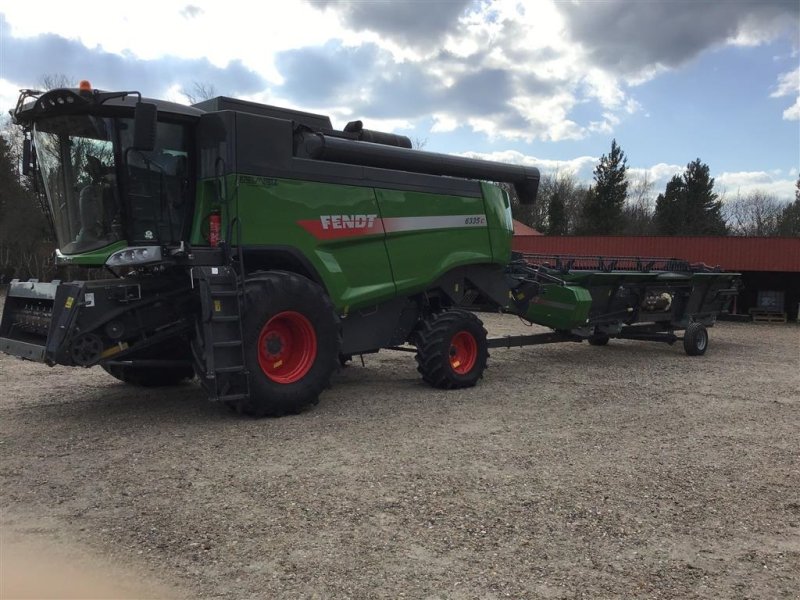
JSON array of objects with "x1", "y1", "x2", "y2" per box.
[{"x1": 655, "y1": 158, "x2": 728, "y2": 235}]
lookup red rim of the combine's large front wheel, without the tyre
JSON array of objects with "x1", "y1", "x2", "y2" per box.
[{"x1": 258, "y1": 310, "x2": 317, "y2": 383}]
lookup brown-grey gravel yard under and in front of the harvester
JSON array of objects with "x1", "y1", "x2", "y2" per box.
[{"x1": 0, "y1": 304, "x2": 800, "y2": 598}]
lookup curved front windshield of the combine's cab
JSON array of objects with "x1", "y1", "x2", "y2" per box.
[{"x1": 33, "y1": 116, "x2": 123, "y2": 254}]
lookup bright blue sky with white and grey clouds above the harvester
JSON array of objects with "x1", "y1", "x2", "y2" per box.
[{"x1": 0, "y1": 0, "x2": 800, "y2": 201}]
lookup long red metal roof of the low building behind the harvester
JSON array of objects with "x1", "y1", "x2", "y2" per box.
[{"x1": 513, "y1": 236, "x2": 800, "y2": 272}]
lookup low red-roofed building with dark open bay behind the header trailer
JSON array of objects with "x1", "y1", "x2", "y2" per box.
[{"x1": 514, "y1": 233, "x2": 800, "y2": 319}]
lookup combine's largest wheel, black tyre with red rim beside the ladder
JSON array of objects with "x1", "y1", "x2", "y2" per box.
[{"x1": 238, "y1": 271, "x2": 341, "y2": 417}]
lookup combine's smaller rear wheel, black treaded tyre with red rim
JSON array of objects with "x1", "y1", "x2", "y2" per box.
[{"x1": 416, "y1": 309, "x2": 489, "y2": 390}]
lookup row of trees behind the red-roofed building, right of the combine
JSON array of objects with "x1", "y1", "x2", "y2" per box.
[{"x1": 507, "y1": 140, "x2": 800, "y2": 236}]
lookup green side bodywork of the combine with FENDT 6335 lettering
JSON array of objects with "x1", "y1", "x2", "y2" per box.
[{"x1": 191, "y1": 175, "x2": 513, "y2": 310}]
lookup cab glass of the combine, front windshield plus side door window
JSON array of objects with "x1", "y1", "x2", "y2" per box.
[{"x1": 33, "y1": 115, "x2": 191, "y2": 254}]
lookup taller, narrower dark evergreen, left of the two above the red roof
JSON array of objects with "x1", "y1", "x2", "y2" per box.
[{"x1": 582, "y1": 140, "x2": 628, "y2": 235}]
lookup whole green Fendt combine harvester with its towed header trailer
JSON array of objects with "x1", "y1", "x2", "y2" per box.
[{"x1": 0, "y1": 82, "x2": 735, "y2": 415}]
